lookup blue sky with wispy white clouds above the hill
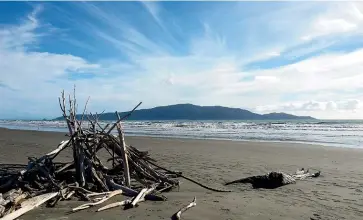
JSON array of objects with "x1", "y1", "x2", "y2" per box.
[{"x1": 0, "y1": 1, "x2": 363, "y2": 119}]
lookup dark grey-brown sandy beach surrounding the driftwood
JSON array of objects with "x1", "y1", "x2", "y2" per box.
[{"x1": 0, "y1": 129, "x2": 363, "y2": 220}]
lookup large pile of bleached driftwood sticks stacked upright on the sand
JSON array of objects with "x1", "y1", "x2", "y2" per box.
[{"x1": 0, "y1": 92, "x2": 202, "y2": 219}]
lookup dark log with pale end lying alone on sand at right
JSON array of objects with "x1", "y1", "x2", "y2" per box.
[{"x1": 225, "y1": 168, "x2": 320, "y2": 189}]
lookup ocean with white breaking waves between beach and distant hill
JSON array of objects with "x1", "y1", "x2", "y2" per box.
[{"x1": 0, "y1": 120, "x2": 363, "y2": 148}]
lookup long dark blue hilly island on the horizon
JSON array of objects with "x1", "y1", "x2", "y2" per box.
[{"x1": 54, "y1": 104, "x2": 314, "y2": 120}]
